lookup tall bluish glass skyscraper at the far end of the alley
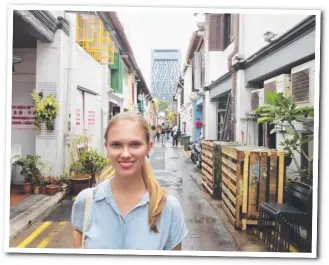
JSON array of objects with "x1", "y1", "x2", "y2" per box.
[{"x1": 151, "y1": 50, "x2": 181, "y2": 104}]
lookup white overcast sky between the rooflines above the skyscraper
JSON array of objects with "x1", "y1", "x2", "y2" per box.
[{"x1": 118, "y1": 10, "x2": 196, "y2": 90}]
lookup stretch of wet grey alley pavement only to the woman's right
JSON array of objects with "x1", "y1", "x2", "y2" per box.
[{"x1": 150, "y1": 142, "x2": 239, "y2": 251}]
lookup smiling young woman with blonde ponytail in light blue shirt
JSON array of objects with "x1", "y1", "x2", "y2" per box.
[{"x1": 72, "y1": 112, "x2": 187, "y2": 250}]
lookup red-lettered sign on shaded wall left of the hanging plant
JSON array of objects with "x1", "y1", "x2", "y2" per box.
[{"x1": 11, "y1": 105, "x2": 35, "y2": 128}]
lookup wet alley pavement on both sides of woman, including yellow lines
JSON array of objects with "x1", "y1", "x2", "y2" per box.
[{"x1": 10, "y1": 142, "x2": 239, "y2": 251}]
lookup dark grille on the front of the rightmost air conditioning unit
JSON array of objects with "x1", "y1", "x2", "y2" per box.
[{"x1": 292, "y1": 69, "x2": 310, "y2": 102}]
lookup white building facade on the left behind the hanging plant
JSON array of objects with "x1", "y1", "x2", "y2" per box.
[{"x1": 11, "y1": 10, "x2": 152, "y2": 182}]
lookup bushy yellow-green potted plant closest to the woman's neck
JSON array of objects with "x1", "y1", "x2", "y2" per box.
[{"x1": 81, "y1": 149, "x2": 107, "y2": 186}]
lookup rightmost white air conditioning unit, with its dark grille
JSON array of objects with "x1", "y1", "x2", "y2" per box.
[{"x1": 291, "y1": 60, "x2": 315, "y2": 106}]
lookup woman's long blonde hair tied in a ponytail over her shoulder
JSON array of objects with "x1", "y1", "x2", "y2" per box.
[{"x1": 97, "y1": 112, "x2": 167, "y2": 233}]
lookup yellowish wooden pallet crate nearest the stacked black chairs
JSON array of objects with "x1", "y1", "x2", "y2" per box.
[{"x1": 221, "y1": 146, "x2": 284, "y2": 230}]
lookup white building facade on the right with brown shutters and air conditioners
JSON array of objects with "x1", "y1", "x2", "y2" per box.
[{"x1": 176, "y1": 11, "x2": 316, "y2": 177}]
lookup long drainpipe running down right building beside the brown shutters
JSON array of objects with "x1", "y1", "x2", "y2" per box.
[{"x1": 228, "y1": 14, "x2": 239, "y2": 141}]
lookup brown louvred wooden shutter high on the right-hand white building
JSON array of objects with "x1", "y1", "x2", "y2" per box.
[{"x1": 209, "y1": 14, "x2": 224, "y2": 51}]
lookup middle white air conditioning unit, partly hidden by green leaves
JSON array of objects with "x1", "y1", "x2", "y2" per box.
[{"x1": 264, "y1": 74, "x2": 291, "y2": 103}]
